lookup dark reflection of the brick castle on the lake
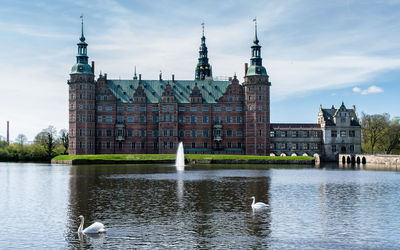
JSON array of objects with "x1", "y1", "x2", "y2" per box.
[{"x1": 66, "y1": 166, "x2": 271, "y2": 248}]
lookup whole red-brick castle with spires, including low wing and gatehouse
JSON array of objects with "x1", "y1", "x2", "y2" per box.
[{"x1": 68, "y1": 22, "x2": 361, "y2": 160}]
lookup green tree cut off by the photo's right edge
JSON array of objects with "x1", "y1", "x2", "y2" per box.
[{"x1": 379, "y1": 118, "x2": 400, "y2": 154}]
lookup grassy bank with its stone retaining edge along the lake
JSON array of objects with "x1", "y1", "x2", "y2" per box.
[{"x1": 52, "y1": 154, "x2": 314, "y2": 163}]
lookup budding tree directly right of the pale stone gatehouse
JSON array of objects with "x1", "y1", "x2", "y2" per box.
[{"x1": 361, "y1": 113, "x2": 390, "y2": 154}]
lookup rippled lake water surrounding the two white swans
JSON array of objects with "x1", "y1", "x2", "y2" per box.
[{"x1": 0, "y1": 163, "x2": 400, "y2": 249}]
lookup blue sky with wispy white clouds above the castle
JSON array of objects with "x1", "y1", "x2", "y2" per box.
[{"x1": 0, "y1": 0, "x2": 400, "y2": 140}]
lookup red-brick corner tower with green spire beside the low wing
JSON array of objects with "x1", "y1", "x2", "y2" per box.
[{"x1": 243, "y1": 19, "x2": 271, "y2": 155}]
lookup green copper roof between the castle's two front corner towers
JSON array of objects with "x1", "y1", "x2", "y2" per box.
[{"x1": 107, "y1": 80, "x2": 231, "y2": 103}]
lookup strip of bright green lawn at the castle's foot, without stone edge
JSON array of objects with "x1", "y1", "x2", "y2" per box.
[{"x1": 53, "y1": 154, "x2": 314, "y2": 161}]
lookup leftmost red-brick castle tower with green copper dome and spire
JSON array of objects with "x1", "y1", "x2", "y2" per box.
[{"x1": 68, "y1": 16, "x2": 95, "y2": 155}]
